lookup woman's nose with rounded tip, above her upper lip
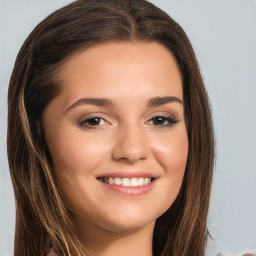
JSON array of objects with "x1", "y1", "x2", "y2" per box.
[{"x1": 112, "y1": 125, "x2": 150, "y2": 163}]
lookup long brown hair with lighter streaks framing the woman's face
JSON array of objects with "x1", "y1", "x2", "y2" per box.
[{"x1": 7, "y1": 0, "x2": 214, "y2": 256}]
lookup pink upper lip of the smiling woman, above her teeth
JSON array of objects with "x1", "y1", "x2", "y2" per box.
[{"x1": 97, "y1": 170, "x2": 158, "y2": 178}]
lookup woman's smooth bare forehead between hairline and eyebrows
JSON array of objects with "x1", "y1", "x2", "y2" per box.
[{"x1": 59, "y1": 42, "x2": 183, "y2": 104}]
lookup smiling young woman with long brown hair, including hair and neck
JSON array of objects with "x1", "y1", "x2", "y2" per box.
[{"x1": 8, "y1": 0, "x2": 214, "y2": 256}]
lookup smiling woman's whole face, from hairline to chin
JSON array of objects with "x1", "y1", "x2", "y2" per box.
[{"x1": 43, "y1": 42, "x2": 188, "y2": 232}]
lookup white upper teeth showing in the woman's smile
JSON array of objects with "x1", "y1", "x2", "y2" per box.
[{"x1": 100, "y1": 177, "x2": 151, "y2": 187}]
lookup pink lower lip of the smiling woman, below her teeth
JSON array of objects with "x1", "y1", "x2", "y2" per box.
[{"x1": 99, "y1": 180, "x2": 156, "y2": 196}]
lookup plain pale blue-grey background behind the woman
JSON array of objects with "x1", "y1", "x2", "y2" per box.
[{"x1": 0, "y1": 0, "x2": 256, "y2": 256}]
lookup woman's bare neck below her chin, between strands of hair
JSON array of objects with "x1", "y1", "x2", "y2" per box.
[{"x1": 74, "y1": 216, "x2": 155, "y2": 256}]
